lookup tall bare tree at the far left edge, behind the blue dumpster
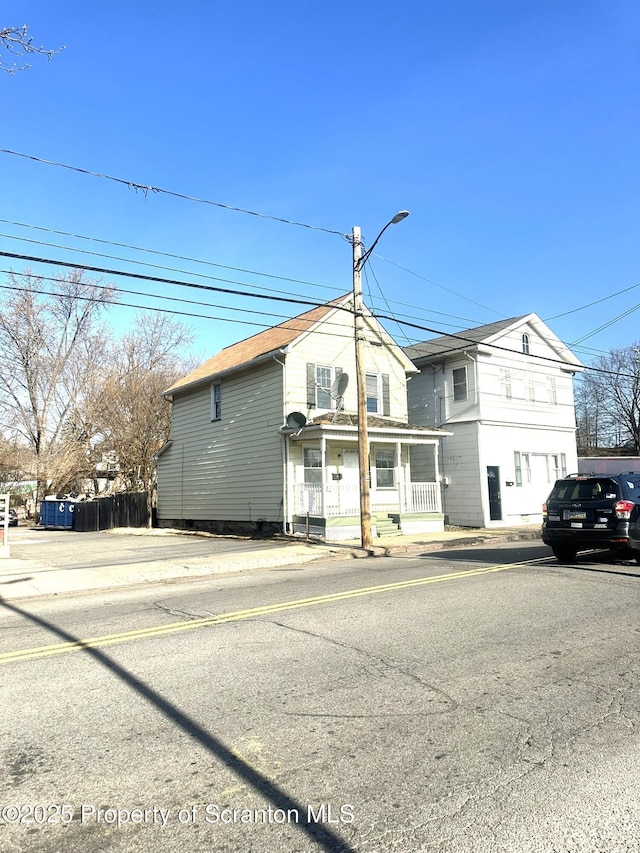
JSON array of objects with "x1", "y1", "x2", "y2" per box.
[{"x1": 0, "y1": 271, "x2": 115, "y2": 499}]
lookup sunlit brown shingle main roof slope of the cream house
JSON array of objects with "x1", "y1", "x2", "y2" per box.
[{"x1": 164, "y1": 294, "x2": 351, "y2": 394}]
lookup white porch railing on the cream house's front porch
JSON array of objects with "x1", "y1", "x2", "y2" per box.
[{"x1": 294, "y1": 481, "x2": 442, "y2": 518}]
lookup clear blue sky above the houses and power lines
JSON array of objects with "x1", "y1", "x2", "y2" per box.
[{"x1": 0, "y1": 0, "x2": 640, "y2": 363}]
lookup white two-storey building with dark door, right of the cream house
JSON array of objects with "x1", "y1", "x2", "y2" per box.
[{"x1": 404, "y1": 314, "x2": 583, "y2": 527}]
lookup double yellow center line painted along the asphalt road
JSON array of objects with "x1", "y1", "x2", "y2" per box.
[{"x1": 0, "y1": 557, "x2": 548, "y2": 665}]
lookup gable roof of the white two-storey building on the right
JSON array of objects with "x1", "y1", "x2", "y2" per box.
[{"x1": 404, "y1": 313, "x2": 583, "y2": 368}]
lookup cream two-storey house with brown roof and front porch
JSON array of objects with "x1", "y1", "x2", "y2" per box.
[{"x1": 157, "y1": 295, "x2": 444, "y2": 540}]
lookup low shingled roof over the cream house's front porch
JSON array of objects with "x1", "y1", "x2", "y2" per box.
[{"x1": 291, "y1": 412, "x2": 453, "y2": 444}]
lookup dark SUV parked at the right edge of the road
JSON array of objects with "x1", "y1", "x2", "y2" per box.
[{"x1": 542, "y1": 473, "x2": 640, "y2": 563}]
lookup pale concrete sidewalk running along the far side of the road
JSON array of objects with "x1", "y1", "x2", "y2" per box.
[{"x1": 0, "y1": 524, "x2": 540, "y2": 601}]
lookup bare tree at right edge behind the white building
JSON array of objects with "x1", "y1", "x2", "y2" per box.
[{"x1": 576, "y1": 343, "x2": 640, "y2": 454}]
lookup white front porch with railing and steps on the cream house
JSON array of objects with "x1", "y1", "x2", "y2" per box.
[{"x1": 288, "y1": 419, "x2": 444, "y2": 541}]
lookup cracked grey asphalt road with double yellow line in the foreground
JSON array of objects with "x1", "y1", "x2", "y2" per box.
[{"x1": 0, "y1": 543, "x2": 640, "y2": 853}]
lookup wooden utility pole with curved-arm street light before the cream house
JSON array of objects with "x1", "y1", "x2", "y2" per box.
[{"x1": 351, "y1": 210, "x2": 409, "y2": 548}]
